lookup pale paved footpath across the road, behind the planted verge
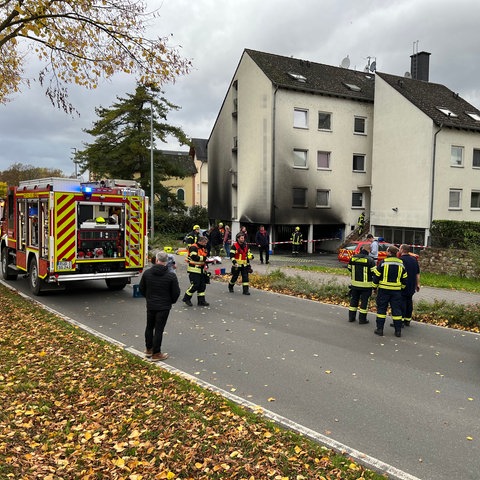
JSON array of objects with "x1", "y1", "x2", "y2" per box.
[{"x1": 248, "y1": 255, "x2": 480, "y2": 305}]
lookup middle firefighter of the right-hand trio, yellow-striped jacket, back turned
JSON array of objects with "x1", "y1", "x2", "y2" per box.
[{"x1": 373, "y1": 245, "x2": 408, "y2": 337}]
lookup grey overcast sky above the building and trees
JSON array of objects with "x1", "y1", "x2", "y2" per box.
[{"x1": 0, "y1": 0, "x2": 480, "y2": 175}]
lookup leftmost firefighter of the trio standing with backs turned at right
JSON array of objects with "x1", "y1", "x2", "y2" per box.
[{"x1": 347, "y1": 243, "x2": 375, "y2": 325}]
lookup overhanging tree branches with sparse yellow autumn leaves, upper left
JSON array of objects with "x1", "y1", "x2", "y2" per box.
[{"x1": 0, "y1": 0, "x2": 190, "y2": 111}]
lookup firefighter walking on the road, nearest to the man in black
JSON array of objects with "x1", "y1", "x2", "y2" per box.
[{"x1": 183, "y1": 236, "x2": 210, "y2": 307}]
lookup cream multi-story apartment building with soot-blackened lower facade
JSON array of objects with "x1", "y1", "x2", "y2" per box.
[{"x1": 208, "y1": 50, "x2": 480, "y2": 250}]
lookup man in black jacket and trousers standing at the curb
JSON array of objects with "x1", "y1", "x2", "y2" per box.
[{"x1": 139, "y1": 251, "x2": 180, "y2": 362}]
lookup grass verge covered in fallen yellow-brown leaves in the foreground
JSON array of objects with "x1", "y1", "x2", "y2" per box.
[{"x1": 0, "y1": 285, "x2": 385, "y2": 480}]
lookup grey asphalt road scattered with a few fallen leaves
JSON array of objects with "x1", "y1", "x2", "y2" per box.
[{"x1": 3, "y1": 258, "x2": 480, "y2": 480}]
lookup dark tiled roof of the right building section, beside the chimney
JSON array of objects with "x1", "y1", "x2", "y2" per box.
[{"x1": 377, "y1": 72, "x2": 480, "y2": 131}]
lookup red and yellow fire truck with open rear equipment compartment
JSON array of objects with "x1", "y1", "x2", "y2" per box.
[{"x1": 0, "y1": 177, "x2": 148, "y2": 295}]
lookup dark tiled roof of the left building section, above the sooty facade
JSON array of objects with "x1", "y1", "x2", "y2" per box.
[{"x1": 245, "y1": 49, "x2": 375, "y2": 102}]
